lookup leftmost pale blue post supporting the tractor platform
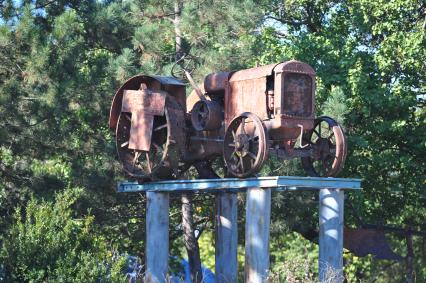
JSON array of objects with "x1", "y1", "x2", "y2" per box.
[{"x1": 145, "y1": 192, "x2": 169, "y2": 283}]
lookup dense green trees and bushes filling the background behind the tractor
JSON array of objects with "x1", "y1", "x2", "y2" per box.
[{"x1": 0, "y1": 0, "x2": 426, "y2": 282}]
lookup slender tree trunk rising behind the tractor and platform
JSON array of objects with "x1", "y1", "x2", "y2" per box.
[{"x1": 173, "y1": 0, "x2": 203, "y2": 283}]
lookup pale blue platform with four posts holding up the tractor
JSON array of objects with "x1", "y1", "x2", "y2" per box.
[{"x1": 117, "y1": 176, "x2": 361, "y2": 283}]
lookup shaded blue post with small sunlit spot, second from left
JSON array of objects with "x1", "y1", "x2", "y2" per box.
[{"x1": 215, "y1": 192, "x2": 238, "y2": 283}]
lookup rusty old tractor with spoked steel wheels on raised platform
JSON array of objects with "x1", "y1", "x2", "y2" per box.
[{"x1": 109, "y1": 60, "x2": 347, "y2": 182}]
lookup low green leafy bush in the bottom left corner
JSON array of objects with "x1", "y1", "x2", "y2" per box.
[{"x1": 1, "y1": 189, "x2": 125, "y2": 282}]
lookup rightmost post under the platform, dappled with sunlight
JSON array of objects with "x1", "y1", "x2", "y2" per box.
[{"x1": 319, "y1": 189, "x2": 344, "y2": 283}]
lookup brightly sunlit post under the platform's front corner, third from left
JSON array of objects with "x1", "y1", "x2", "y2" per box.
[{"x1": 245, "y1": 188, "x2": 271, "y2": 283}]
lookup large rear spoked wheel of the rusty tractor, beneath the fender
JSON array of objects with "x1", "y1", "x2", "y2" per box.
[{"x1": 116, "y1": 97, "x2": 182, "y2": 181}]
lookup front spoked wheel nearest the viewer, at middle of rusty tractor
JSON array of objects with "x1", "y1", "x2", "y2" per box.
[{"x1": 223, "y1": 112, "x2": 268, "y2": 178}]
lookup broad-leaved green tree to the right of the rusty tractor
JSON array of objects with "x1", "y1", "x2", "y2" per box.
[{"x1": 253, "y1": 0, "x2": 426, "y2": 280}]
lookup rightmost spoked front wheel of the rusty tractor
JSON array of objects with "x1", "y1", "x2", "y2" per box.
[{"x1": 301, "y1": 117, "x2": 347, "y2": 177}]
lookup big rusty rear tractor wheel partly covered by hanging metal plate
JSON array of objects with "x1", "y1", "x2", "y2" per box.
[{"x1": 116, "y1": 96, "x2": 185, "y2": 182}]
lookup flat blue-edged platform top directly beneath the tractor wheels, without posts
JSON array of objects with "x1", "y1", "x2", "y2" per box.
[{"x1": 117, "y1": 176, "x2": 361, "y2": 193}]
